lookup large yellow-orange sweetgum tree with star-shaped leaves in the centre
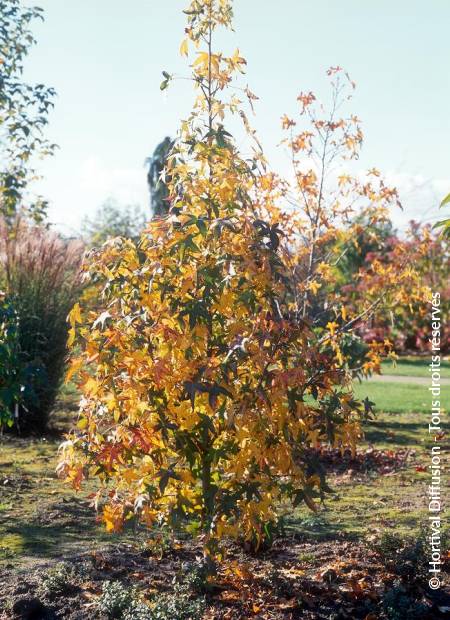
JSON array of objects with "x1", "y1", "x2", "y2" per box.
[{"x1": 59, "y1": 0, "x2": 424, "y2": 557}]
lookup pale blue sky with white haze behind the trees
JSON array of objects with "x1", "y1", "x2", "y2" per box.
[{"x1": 26, "y1": 0, "x2": 450, "y2": 234}]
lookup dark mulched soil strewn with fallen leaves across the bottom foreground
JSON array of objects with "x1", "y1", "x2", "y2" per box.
[{"x1": 0, "y1": 538, "x2": 450, "y2": 620}]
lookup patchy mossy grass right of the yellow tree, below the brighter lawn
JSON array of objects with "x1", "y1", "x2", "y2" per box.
[{"x1": 287, "y1": 413, "x2": 436, "y2": 541}]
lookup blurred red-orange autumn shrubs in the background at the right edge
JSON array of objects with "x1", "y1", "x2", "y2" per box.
[{"x1": 341, "y1": 222, "x2": 450, "y2": 353}]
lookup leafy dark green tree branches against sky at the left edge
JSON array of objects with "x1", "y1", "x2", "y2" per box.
[{"x1": 0, "y1": 0, "x2": 55, "y2": 221}]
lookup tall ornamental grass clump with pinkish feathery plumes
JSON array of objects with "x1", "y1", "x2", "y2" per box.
[{"x1": 0, "y1": 221, "x2": 83, "y2": 431}]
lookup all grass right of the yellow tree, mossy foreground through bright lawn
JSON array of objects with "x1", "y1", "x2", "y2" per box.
[{"x1": 287, "y1": 358, "x2": 450, "y2": 540}]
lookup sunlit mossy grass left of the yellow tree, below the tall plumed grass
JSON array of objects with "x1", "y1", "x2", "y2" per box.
[{"x1": 0, "y1": 426, "x2": 136, "y2": 566}]
